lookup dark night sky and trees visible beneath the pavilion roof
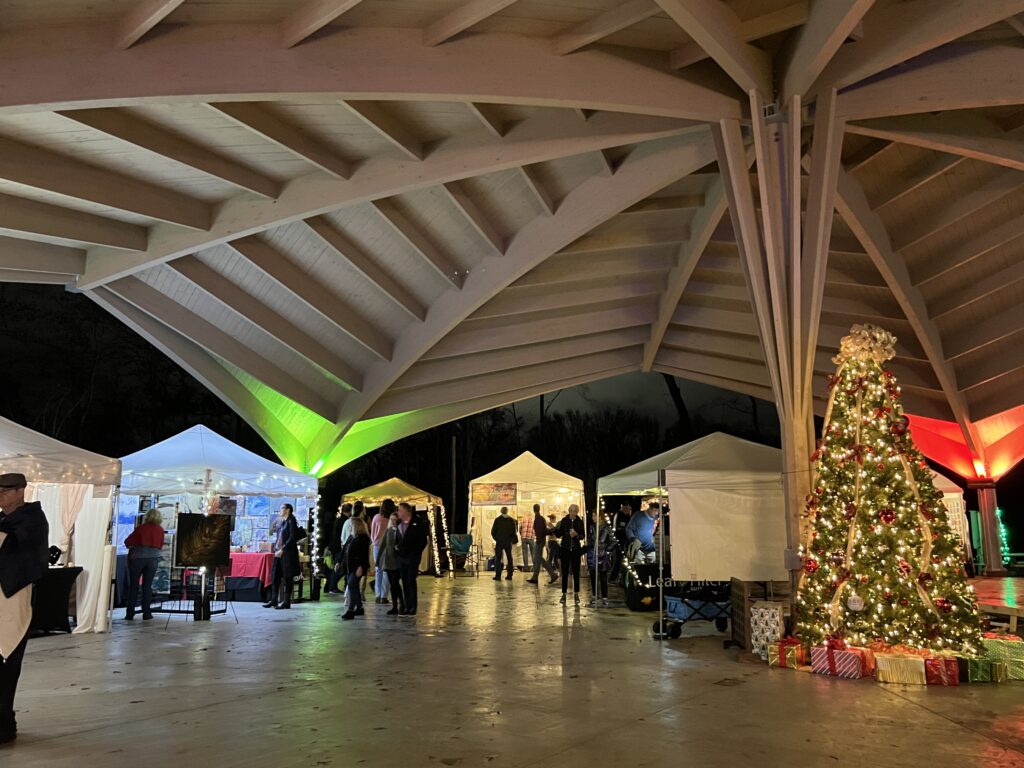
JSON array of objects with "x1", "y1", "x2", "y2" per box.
[{"x1": 0, "y1": 284, "x2": 1024, "y2": 551}]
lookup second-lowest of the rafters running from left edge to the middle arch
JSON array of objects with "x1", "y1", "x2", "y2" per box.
[{"x1": 0, "y1": 194, "x2": 148, "y2": 251}]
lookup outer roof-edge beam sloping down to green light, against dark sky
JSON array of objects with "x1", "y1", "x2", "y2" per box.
[{"x1": 84, "y1": 288, "x2": 307, "y2": 469}]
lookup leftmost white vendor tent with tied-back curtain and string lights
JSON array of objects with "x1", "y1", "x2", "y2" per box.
[{"x1": 0, "y1": 419, "x2": 121, "y2": 633}]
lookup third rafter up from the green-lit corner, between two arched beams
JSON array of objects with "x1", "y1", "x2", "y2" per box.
[{"x1": 228, "y1": 236, "x2": 393, "y2": 360}]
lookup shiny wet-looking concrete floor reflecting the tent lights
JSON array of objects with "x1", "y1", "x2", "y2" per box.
[{"x1": 6, "y1": 574, "x2": 1024, "y2": 768}]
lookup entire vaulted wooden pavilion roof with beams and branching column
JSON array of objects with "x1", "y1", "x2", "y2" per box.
[{"x1": 0, "y1": 0, "x2": 1024, "y2": 473}]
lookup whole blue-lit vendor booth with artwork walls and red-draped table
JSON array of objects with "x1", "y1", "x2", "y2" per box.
[{"x1": 114, "y1": 426, "x2": 317, "y2": 600}]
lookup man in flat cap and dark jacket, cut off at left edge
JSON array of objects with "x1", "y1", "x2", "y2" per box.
[{"x1": 0, "y1": 472, "x2": 50, "y2": 744}]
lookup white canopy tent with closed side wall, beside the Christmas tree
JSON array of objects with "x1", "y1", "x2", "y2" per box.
[{"x1": 597, "y1": 432, "x2": 788, "y2": 582}]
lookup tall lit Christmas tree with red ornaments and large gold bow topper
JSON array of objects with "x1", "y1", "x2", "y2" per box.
[{"x1": 797, "y1": 326, "x2": 981, "y2": 653}]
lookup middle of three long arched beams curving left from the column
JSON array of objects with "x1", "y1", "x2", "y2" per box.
[{"x1": 79, "y1": 110, "x2": 688, "y2": 290}]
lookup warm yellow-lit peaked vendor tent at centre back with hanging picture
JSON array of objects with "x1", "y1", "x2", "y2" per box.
[{"x1": 469, "y1": 451, "x2": 584, "y2": 565}]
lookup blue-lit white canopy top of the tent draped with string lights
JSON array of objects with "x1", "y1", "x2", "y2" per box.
[{"x1": 121, "y1": 425, "x2": 317, "y2": 498}]
